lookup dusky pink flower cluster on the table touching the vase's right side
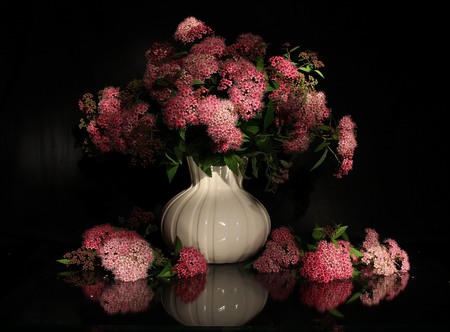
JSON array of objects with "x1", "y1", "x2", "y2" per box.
[{"x1": 253, "y1": 226, "x2": 300, "y2": 273}]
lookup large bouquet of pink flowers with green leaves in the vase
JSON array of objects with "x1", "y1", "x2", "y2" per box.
[{"x1": 79, "y1": 17, "x2": 357, "y2": 191}]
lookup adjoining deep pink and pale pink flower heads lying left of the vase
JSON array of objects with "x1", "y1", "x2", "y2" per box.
[{"x1": 83, "y1": 224, "x2": 155, "y2": 281}]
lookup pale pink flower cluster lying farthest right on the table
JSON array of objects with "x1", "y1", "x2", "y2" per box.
[{"x1": 361, "y1": 228, "x2": 410, "y2": 276}]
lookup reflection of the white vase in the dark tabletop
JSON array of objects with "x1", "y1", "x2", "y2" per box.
[{"x1": 161, "y1": 264, "x2": 268, "y2": 326}]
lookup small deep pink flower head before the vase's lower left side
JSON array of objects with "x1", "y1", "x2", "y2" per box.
[{"x1": 173, "y1": 247, "x2": 208, "y2": 278}]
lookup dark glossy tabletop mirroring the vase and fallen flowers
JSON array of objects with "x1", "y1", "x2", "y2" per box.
[{"x1": 1, "y1": 242, "x2": 450, "y2": 331}]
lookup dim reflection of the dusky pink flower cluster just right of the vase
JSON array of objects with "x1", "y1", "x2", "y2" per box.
[{"x1": 255, "y1": 270, "x2": 297, "y2": 301}]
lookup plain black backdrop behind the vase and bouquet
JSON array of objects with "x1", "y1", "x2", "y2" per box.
[{"x1": 0, "y1": 0, "x2": 449, "y2": 254}]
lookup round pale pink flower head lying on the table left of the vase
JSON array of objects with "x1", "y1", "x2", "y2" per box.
[{"x1": 98, "y1": 230, "x2": 155, "y2": 281}]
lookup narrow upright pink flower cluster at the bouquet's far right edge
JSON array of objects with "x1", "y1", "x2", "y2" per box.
[{"x1": 336, "y1": 115, "x2": 357, "y2": 178}]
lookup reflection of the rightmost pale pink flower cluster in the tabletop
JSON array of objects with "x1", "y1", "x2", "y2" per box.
[{"x1": 360, "y1": 273, "x2": 409, "y2": 306}]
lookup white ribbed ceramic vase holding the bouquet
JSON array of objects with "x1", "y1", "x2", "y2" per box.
[{"x1": 161, "y1": 157, "x2": 271, "y2": 264}]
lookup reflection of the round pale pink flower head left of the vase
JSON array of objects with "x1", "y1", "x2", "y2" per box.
[{"x1": 99, "y1": 279, "x2": 154, "y2": 315}]
